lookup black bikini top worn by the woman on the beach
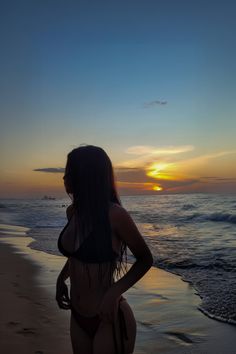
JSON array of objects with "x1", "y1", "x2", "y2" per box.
[{"x1": 58, "y1": 213, "x2": 119, "y2": 263}]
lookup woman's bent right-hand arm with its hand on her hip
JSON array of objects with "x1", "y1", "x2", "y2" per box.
[{"x1": 101, "y1": 206, "x2": 153, "y2": 320}]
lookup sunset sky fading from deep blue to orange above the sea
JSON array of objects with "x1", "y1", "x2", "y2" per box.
[{"x1": 0, "y1": 0, "x2": 236, "y2": 198}]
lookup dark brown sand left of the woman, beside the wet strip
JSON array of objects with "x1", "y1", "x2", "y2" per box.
[{"x1": 0, "y1": 238, "x2": 72, "y2": 354}]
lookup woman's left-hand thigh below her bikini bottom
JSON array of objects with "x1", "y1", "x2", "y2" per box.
[{"x1": 70, "y1": 315, "x2": 93, "y2": 354}]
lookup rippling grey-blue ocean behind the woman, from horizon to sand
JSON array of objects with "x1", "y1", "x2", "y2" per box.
[{"x1": 0, "y1": 194, "x2": 236, "y2": 324}]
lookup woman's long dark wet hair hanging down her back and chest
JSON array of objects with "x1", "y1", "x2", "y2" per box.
[{"x1": 64, "y1": 145, "x2": 127, "y2": 274}]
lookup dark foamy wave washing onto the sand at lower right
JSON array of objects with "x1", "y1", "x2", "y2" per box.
[{"x1": 155, "y1": 259, "x2": 236, "y2": 325}]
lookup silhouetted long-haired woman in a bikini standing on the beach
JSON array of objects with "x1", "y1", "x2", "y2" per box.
[{"x1": 56, "y1": 145, "x2": 153, "y2": 354}]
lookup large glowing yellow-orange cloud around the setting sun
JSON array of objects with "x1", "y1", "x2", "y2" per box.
[{"x1": 116, "y1": 145, "x2": 236, "y2": 192}]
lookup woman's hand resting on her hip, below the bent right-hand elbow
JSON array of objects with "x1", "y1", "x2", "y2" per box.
[{"x1": 99, "y1": 290, "x2": 119, "y2": 322}]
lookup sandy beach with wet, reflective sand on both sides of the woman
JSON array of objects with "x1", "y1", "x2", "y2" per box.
[{"x1": 0, "y1": 228, "x2": 236, "y2": 354}]
